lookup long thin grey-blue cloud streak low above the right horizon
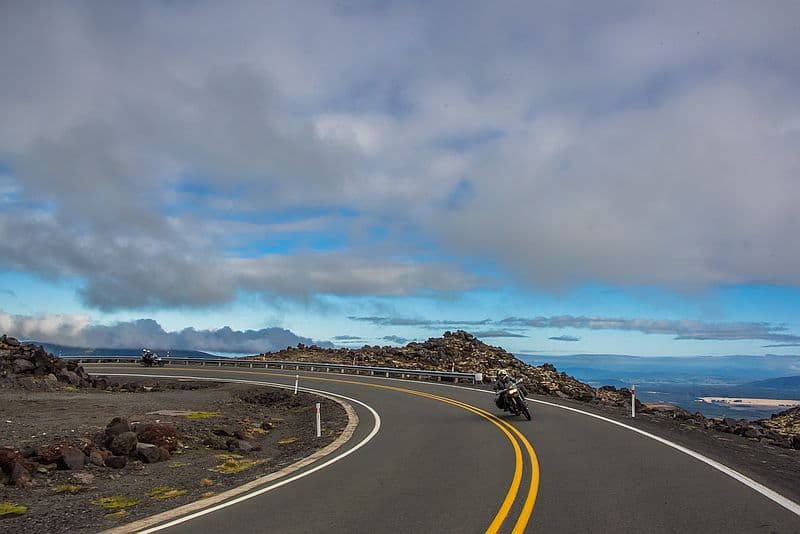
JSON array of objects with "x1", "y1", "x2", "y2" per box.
[{"x1": 498, "y1": 315, "x2": 800, "y2": 342}]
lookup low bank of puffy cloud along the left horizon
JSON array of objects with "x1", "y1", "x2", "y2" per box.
[{"x1": 0, "y1": 311, "x2": 331, "y2": 354}]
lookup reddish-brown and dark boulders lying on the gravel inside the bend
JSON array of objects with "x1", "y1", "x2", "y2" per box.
[{"x1": 0, "y1": 417, "x2": 180, "y2": 488}]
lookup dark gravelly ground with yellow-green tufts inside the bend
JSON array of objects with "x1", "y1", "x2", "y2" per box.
[{"x1": 0, "y1": 380, "x2": 347, "y2": 533}]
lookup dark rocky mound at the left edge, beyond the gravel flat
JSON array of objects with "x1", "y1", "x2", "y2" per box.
[{"x1": 0, "y1": 334, "x2": 107, "y2": 389}]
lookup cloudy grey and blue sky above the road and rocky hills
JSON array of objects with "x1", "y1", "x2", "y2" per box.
[{"x1": 0, "y1": 0, "x2": 800, "y2": 356}]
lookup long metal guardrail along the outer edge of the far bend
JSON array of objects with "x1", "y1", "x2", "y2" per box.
[{"x1": 61, "y1": 356, "x2": 483, "y2": 384}]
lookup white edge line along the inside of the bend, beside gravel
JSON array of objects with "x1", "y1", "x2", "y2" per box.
[{"x1": 95, "y1": 373, "x2": 381, "y2": 534}]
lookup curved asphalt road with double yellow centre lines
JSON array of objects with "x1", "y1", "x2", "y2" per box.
[{"x1": 87, "y1": 365, "x2": 800, "y2": 534}]
